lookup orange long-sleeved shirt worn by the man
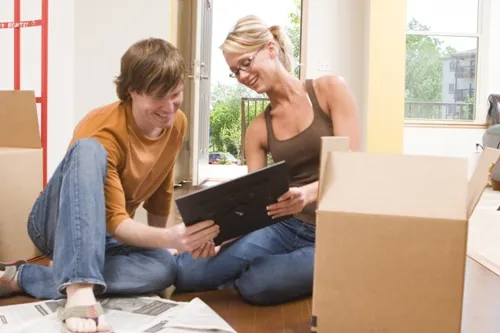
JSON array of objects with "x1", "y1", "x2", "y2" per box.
[{"x1": 70, "y1": 102, "x2": 187, "y2": 236}]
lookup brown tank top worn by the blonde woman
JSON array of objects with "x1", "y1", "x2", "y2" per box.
[{"x1": 265, "y1": 80, "x2": 333, "y2": 224}]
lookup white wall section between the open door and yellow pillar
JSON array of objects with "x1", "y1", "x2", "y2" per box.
[{"x1": 306, "y1": 0, "x2": 370, "y2": 148}]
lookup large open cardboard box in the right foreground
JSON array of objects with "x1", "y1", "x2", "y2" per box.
[{"x1": 312, "y1": 139, "x2": 500, "y2": 333}]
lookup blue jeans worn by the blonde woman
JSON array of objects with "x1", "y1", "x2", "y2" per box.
[{"x1": 175, "y1": 218, "x2": 316, "y2": 305}]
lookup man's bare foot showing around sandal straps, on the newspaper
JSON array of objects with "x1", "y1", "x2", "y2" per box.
[{"x1": 65, "y1": 284, "x2": 110, "y2": 333}]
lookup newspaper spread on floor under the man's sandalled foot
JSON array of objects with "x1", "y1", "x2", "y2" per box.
[{"x1": 0, "y1": 297, "x2": 236, "y2": 333}]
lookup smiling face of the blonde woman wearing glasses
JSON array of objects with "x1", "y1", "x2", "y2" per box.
[{"x1": 224, "y1": 41, "x2": 279, "y2": 94}]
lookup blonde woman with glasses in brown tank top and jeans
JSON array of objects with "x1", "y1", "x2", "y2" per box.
[{"x1": 176, "y1": 16, "x2": 359, "y2": 305}]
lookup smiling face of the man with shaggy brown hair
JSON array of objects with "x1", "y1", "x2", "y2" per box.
[{"x1": 130, "y1": 81, "x2": 184, "y2": 134}]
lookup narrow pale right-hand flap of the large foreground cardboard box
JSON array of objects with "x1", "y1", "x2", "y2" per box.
[{"x1": 467, "y1": 147, "x2": 500, "y2": 217}]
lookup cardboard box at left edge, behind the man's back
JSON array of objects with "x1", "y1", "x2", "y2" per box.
[{"x1": 0, "y1": 91, "x2": 43, "y2": 261}]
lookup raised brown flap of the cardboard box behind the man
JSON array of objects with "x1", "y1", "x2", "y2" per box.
[{"x1": 0, "y1": 90, "x2": 41, "y2": 148}]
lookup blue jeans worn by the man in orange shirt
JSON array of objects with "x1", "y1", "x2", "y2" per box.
[{"x1": 18, "y1": 139, "x2": 177, "y2": 299}]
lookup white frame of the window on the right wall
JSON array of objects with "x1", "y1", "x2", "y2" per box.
[{"x1": 404, "y1": 0, "x2": 491, "y2": 128}]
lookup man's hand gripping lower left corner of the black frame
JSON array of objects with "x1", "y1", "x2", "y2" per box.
[{"x1": 166, "y1": 221, "x2": 219, "y2": 255}]
